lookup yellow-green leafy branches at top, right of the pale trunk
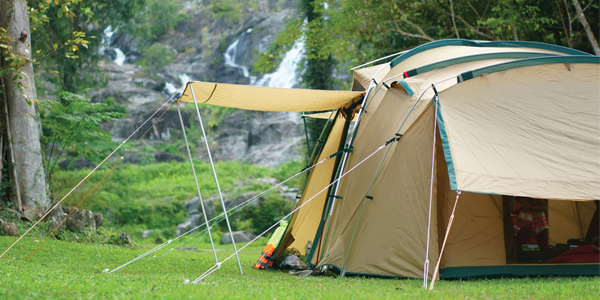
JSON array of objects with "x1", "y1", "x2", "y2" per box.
[{"x1": 27, "y1": 0, "x2": 145, "y2": 92}]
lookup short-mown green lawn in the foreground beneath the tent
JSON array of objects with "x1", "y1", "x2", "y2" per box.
[{"x1": 0, "y1": 237, "x2": 600, "y2": 299}]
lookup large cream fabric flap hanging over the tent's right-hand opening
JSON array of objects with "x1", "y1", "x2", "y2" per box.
[{"x1": 439, "y1": 64, "x2": 600, "y2": 200}]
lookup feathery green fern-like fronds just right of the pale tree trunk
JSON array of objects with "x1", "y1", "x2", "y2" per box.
[{"x1": 40, "y1": 92, "x2": 124, "y2": 180}]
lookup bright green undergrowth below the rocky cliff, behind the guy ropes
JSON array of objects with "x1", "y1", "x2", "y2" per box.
[{"x1": 51, "y1": 160, "x2": 304, "y2": 233}]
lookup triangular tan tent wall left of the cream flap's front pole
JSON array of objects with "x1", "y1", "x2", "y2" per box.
[{"x1": 320, "y1": 106, "x2": 438, "y2": 278}]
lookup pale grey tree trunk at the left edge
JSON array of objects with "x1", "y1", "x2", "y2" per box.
[{"x1": 0, "y1": 0, "x2": 50, "y2": 211}]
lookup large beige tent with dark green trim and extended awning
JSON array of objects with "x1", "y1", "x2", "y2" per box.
[{"x1": 180, "y1": 39, "x2": 600, "y2": 278}]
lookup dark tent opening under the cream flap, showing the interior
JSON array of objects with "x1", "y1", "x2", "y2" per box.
[{"x1": 502, "y1": 196, "x2": 600, "y2": 264}]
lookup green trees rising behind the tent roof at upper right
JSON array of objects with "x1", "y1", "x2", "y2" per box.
[{"x1": 257, "y1": 0, "x2": 600, "y2": 74}]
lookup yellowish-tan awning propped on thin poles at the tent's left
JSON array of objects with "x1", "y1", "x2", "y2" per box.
[{"x1": 179, "y1": 82, "x2": 362, "y2": 112}]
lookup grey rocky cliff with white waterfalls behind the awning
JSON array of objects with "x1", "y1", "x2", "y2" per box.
[{"x1": 91, "y1": 0, "x2": 305, "y2": 166}]
